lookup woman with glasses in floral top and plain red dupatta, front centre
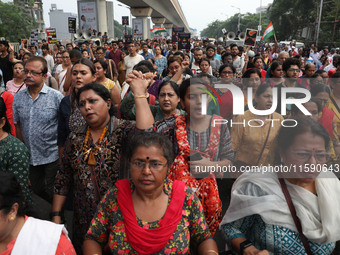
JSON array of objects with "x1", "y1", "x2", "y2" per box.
[{"x1": 84, "y1": 132, "x2": 218, "y2": 255}]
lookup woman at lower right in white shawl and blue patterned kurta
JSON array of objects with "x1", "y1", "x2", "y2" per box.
[{"x1": 220, "y1": 117, "x2": 340, "y2": 255}]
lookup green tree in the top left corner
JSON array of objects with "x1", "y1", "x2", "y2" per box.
[{"x1": 0, "y1": 2, "x2": 36, "y2": 42}]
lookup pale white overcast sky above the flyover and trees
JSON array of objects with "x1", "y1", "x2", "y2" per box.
[{"x1": 4, "y1": 0, "x2": 273, "y2": 31}]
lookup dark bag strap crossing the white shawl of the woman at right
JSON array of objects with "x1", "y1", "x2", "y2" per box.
[{"x1": 279, "y1": 178, "x2": 313, "y2": 255}]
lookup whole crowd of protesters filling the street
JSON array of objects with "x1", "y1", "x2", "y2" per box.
[{"x1": 0, "y1": 35, "x2": 340, "y2": 255}]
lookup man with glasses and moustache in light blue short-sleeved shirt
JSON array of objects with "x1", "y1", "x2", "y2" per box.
[{"x1": 13, "y1": 57, "x2": 63, "y2": 207}]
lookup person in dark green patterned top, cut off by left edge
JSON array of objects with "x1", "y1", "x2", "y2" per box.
[{"x1": 0, "y1": 97, "x2": 32, "y2": 203}]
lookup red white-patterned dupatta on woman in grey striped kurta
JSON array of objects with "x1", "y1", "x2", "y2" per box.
[{"x1": 168, "y1": 115, "x2": 222, "y2": 236}]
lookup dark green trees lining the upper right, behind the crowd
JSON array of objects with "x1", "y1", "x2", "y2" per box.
[{"x1": 201, "y1": 0, "x2": 340, "y2": 46}]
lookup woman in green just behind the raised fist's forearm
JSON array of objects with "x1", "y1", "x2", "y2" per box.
[{"x1": 120, "y1": 81, "x2": 181, "y2": 121}]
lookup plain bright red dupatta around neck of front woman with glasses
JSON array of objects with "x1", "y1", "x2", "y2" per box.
[{"x1": 115, "y1": 179, "x2": 185, "y2": 255}]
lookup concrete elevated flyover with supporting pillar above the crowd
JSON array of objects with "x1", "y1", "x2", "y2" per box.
[{"x1": 118, "y1": 0, "x2": 190, "y2": 39}]
